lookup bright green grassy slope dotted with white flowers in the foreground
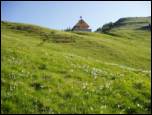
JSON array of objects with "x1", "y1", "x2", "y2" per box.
[{"x1": 1, "y1": 19, "x2": 151, "y2": 113}]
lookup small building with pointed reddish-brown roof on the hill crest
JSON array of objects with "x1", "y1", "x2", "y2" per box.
[{"x1": 72, "y1": 16, "x2": 91, "y2": 32}]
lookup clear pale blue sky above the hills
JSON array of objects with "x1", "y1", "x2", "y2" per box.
[{"x1": 1, "y1": 1, "x2": 151, "y2": 31}]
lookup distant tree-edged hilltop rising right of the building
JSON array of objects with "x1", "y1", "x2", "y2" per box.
[{"x1": 97, "y1": 16, "x2": 151, "y2": 33}]
